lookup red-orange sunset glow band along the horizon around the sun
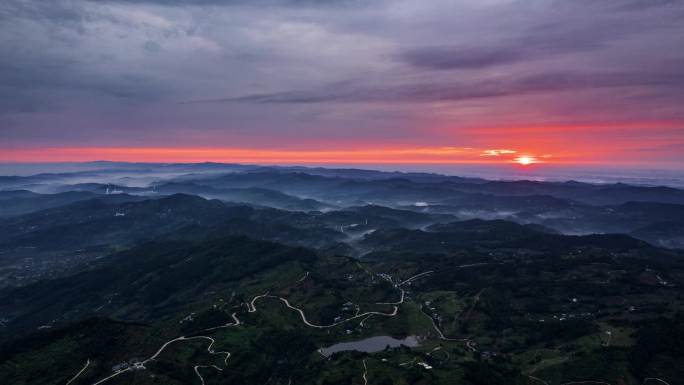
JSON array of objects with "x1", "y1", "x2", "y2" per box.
[{"x1": 0, "y1": 121, "x2": 684, "y2": 166}]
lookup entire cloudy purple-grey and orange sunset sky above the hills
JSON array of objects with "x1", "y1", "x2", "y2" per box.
[{"x1": 0, "y1": 0, "x2": 684, "y2": 169}]
